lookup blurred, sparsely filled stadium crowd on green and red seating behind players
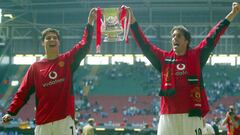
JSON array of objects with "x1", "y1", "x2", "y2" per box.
[{"x1": 0, "y1": 62, "x2": 240, "y2": 134}]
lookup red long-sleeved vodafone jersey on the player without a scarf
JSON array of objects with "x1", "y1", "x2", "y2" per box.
[{"x1": 8, "y1": 24, "x2": 93, "y2": 125}]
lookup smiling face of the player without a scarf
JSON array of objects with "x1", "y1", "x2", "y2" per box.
[{"x1": 42, "y1": 32, "x2": 60, "y2": 51}]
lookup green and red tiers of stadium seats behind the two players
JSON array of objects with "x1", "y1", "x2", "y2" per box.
[{"x1": 1, "y1": 63, "x2": 240, "y2": 126}]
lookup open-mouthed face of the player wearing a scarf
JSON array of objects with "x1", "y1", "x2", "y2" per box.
[{"x1": 172, "y1": 30, "x2": 188, "y2": 55}]
